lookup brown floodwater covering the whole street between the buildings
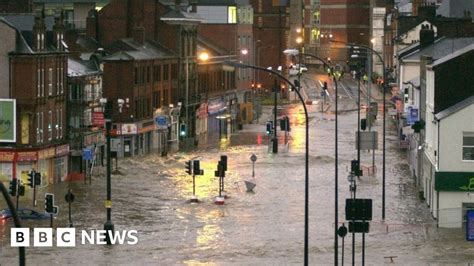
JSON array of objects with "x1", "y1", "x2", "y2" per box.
[{"x1": 0, "y1": 98, "x2": 474, "y2": 266}]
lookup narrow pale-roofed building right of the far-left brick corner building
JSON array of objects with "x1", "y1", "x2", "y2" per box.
[{"x1": 67, "y1": 53, "x2": 105, "y2": 179}]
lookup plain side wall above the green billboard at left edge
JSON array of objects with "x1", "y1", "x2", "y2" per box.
[{"x1": 0, "y1": 22, "x2": 16, "y2": 98}]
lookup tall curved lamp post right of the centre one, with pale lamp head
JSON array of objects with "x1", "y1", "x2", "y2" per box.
[{"x1": 283, "y1": 49, "x2": 339, "y2": 265}]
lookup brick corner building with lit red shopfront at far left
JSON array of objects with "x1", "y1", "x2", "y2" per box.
[{"x1": 0, "y1": 13, "x2": 69, "y2": 184}]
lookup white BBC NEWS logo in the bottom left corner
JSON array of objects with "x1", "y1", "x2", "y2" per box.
[{"x1": 10, "y1": 228, "x2": 138, "y2": 247}]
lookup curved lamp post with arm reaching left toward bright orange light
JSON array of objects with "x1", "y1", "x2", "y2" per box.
[{"x1": 224, "y1": 61, "x2": 309, "y2": 265}]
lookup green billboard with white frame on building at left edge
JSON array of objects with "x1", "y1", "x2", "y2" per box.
[{"x1": 0, "y1": 99, "x2": 16, "y2": 143}]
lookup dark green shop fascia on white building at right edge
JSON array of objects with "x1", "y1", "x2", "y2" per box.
[{"x1": 435, "y1": 172, "x2": 474, "y2": 192}]
